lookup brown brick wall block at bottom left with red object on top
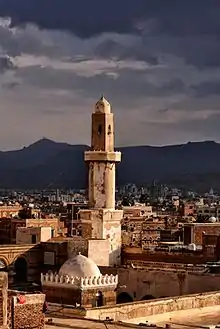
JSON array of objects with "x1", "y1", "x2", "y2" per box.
[{"x1": 8, "y1": 290, "x2": 45, "y2": 329}]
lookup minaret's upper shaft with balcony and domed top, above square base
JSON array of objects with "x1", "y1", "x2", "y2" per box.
[{"x1": 85, "y1": 97, "x2": 121, "y2": 209}]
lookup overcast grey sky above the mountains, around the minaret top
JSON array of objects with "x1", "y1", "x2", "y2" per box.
[{"x1": 0, "y1": 0, "x2": 220, "y2": 150}]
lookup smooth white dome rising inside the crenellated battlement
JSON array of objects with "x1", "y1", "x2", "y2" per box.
[{"x1": 59, "y1": 253, "x2": 101, "y2": 278}]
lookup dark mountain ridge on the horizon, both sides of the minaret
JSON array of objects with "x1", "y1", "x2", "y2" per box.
[{"x1": 0, "y1": 138, "x2": 220, "y2": 190}]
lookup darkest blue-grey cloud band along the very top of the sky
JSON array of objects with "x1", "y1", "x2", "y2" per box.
[{"x1": 0, "y1": 0, "x2": 220, "y2": 37}]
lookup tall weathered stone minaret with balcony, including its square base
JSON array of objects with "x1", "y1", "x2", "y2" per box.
[{"x1": 80, "y1": 97, "x2": 123, "y2": 266}]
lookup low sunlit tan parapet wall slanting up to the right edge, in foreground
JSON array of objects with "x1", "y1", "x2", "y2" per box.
[{"x1": 86, "y1": 292, "x2": 220, "y2": 322}]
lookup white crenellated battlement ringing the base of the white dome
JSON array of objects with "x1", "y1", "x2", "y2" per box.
[{"x1": 41, "y1": 273, "x2": 118, "y2": 289}]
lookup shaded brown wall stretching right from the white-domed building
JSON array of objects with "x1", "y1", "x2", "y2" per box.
[{"x1": 118, "y1": 268, "x2": 220, "y2": 300}]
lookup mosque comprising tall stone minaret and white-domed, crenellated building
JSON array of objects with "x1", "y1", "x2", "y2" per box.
[{"x1": 41, "y1": 97, "x2": 123, "y2": 308}]
